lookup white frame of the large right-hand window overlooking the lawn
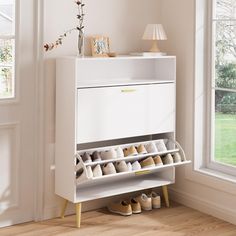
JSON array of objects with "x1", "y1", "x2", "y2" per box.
[{"x1": 204, "y1": 0, "x2": 236, "y2": 176}]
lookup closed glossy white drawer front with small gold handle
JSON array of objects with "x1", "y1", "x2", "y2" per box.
[{"x1": 77, "y1": 82, "x2": 175, "y2": 143}]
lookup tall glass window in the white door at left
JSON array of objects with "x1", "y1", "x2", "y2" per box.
[{"x1": 0, "y1": 0, "x2": 15, "y2": 99}]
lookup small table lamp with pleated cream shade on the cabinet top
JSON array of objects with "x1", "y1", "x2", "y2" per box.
[{"x1": 143, "y1": 24, "x2": 167, "y2": 52}]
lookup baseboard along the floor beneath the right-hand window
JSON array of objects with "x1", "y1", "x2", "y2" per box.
[{"x1": 169, "y1": 188, "x2": 236, "y2": 225}]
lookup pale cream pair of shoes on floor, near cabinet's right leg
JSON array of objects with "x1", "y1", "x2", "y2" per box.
[{"x1": 135, "y1": 191, "x2": 161, "y2": 211}]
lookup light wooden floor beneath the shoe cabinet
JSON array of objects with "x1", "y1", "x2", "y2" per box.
[{"x1": 0, "y1": 204, "x2": 236, "y2": 236}]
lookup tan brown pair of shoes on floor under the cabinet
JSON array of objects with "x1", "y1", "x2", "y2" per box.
[{"x1": 108, "y1": 198, "x2": 142, "y2": 216}]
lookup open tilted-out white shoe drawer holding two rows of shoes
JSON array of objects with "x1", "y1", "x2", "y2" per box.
[{"x1": 75, "y1": 140, "x2": 191, "y2": 186}]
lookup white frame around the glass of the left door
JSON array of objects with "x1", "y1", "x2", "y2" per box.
[{"x1": 0, "y1": 0, "x2": 16, "y2": 100}]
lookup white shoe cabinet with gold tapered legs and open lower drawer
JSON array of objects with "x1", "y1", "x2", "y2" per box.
[{"x1": 55, "y1": 56, "x2": 192, "y2": 227}]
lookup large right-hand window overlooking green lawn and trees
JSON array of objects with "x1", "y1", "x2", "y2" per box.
[{"x1": 208, "y1": 0, "x2": 236, "y2": 174}]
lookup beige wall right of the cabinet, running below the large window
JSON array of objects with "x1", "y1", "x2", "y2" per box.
[{"x1": 160, "y1": 0, "x2": 236, "y2": 224}]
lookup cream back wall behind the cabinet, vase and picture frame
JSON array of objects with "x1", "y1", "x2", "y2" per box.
[{"x1": 44, "y1": 0, "x2": 160, "y2": 217}]
